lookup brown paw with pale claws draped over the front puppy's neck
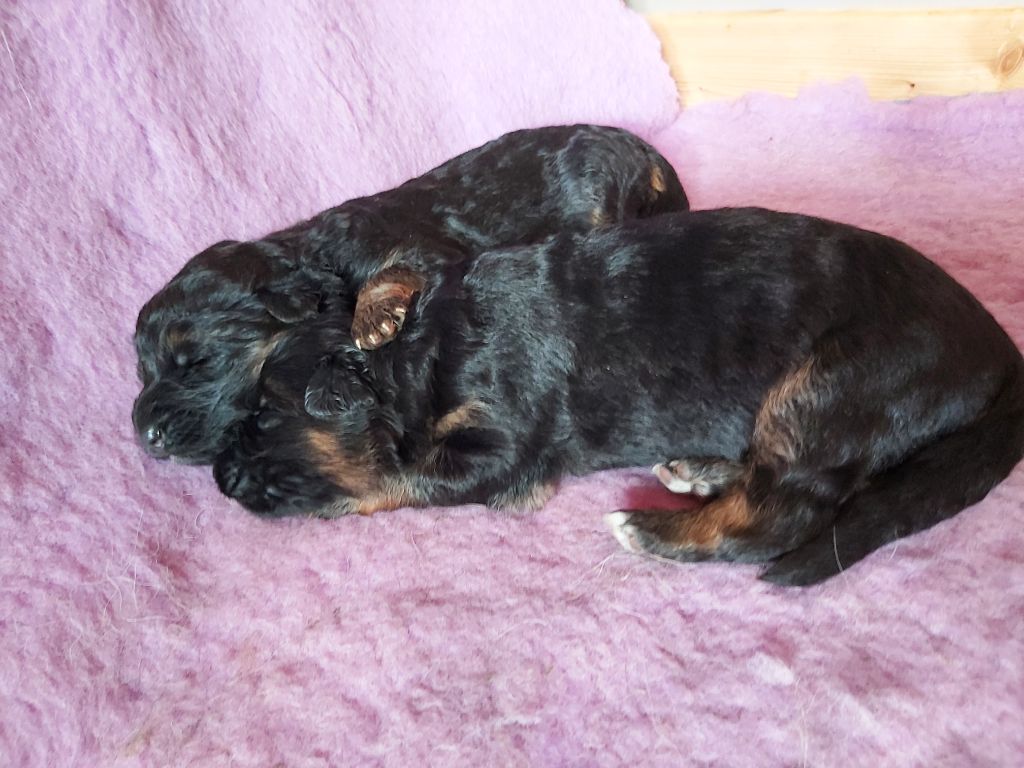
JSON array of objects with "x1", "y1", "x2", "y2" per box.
[{"x1": 352, "y1": 266, "x2": 426, "y2": 349}]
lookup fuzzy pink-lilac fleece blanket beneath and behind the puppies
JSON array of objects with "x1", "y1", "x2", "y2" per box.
[{"x1": 0, "y1": 0, "x2": 1024, "y2": 768}]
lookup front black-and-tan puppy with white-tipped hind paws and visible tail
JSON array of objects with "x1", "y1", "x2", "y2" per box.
[{"x1": 214, "y1": 210, "x2": 1024, "y2": 585}]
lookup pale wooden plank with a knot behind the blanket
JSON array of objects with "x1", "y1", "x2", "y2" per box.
[{"x1": 647, "y1": 7, "x2": 1024, "y2": 104}]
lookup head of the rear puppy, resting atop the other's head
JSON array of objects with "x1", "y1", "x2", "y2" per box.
[{"x1": 132, "y1": 241, "x2": 319, "y2": 464}]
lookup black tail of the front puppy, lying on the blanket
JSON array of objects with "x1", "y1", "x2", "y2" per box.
[{"x1": 761, "y1": 359, "x2": 1024, "y2": 586}]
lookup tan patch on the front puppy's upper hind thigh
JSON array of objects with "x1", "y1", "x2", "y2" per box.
[{"x1": 752, "y1": 357, "x2": 820, "y2": 462}]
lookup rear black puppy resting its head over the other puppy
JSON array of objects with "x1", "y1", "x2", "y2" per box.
[{"x1": 132, "y1": 125, "x2": 687, "y2": 464}]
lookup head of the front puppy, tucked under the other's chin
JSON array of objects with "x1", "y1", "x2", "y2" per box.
[{"x1": 213, "y1": 303, "x2": 402, "y2": 516}]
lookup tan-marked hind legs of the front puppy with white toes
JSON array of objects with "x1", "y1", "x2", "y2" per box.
[{"x1": 608, "y1": 348, "x2": 860, "y2": 562}]
